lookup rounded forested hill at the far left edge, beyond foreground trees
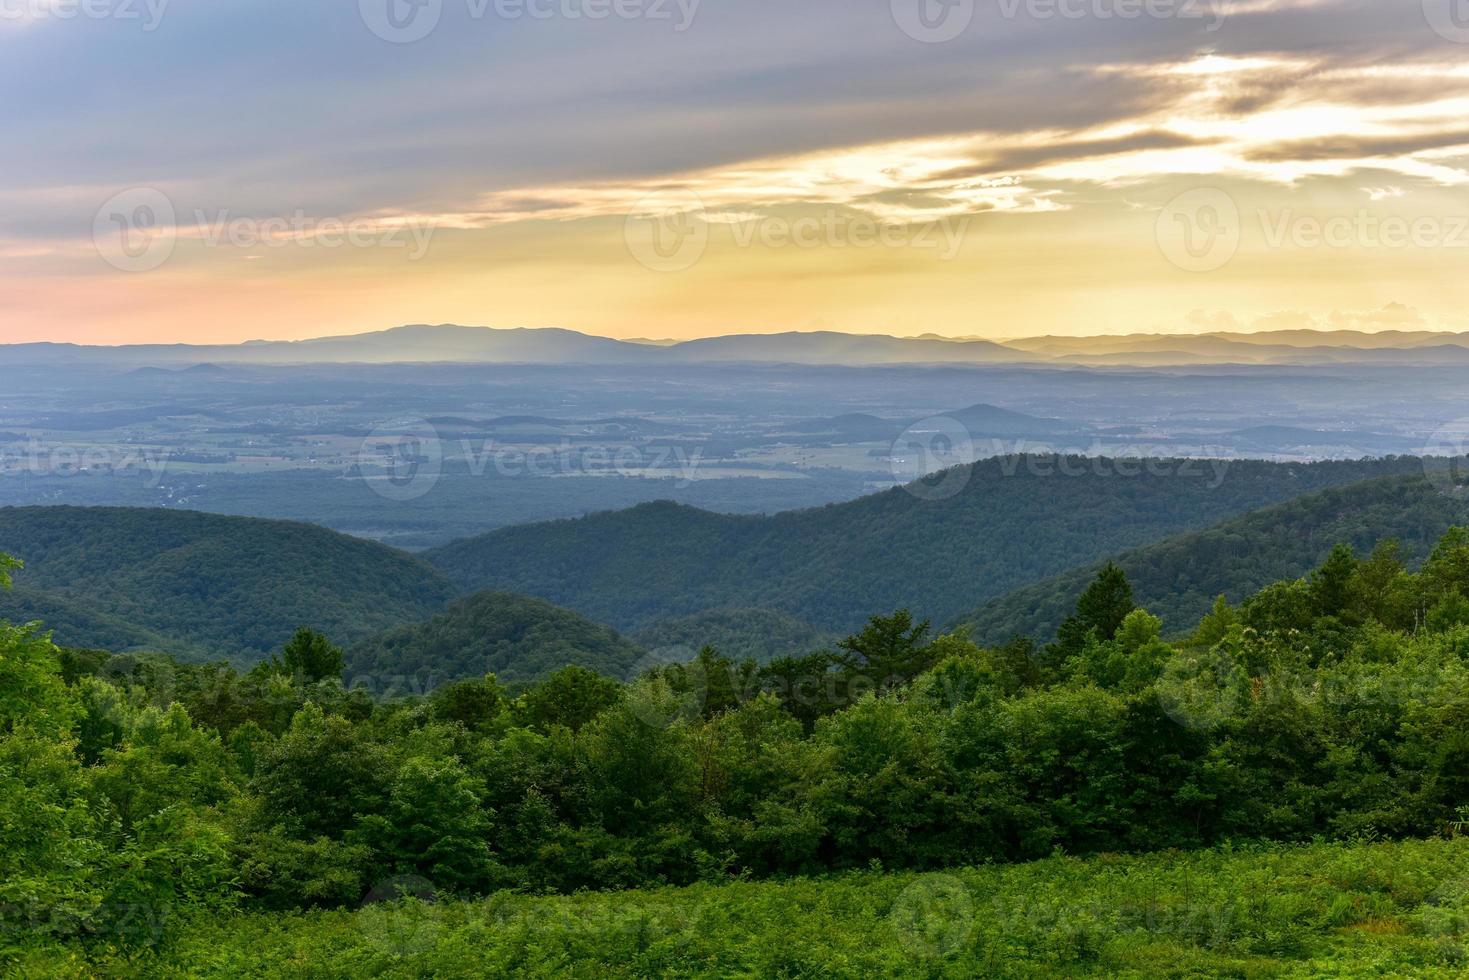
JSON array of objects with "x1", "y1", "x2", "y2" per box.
[{"x1": 0, "y1": 507, "x2": 455, "y2": 661}]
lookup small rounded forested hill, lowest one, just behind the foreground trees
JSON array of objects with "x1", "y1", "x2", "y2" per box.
[{"x1": 347, "y1": 592, "x2": 643, "y2": 689}]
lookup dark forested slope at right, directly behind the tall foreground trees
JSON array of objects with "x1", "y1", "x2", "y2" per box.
[{"x1": 962, "y1": 478, "x2": 1469, "y2": 644}]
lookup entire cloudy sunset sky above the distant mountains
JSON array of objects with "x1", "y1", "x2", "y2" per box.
[{"x1": 0, "y1": 0, "x2": 1469, "y2": 344}]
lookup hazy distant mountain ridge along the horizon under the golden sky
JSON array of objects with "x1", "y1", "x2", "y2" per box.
[{"x1": 0, "y1": 323, "x2": 1469, "y2": 372}]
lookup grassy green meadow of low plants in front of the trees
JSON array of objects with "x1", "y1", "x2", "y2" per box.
[{"x1": 20, "y1": 837, "x2": 1469, "y2": 980}]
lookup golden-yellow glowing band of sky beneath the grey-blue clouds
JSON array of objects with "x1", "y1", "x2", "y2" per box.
[{"x1": 0, "y1": 14, "x2": 1469, "y2": 344}]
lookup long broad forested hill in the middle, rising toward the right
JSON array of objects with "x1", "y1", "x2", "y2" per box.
[{"x1": 425, "y1": 457, "x2": 1422, "y2": 630}]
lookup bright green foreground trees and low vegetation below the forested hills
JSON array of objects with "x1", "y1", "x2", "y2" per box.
[{"x1": 14, "y1": 527, "x2": 1469, "y2": 976}]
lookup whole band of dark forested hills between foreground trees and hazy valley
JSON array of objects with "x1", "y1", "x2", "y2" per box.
[{"x1": 0, "y1": 457, "x2": 1469, "y2": 685}]
